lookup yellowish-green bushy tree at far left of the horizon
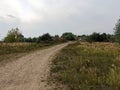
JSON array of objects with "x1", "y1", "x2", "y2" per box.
[{"x1": 4, "y1": 28, "x2": 24, "y2": 43}]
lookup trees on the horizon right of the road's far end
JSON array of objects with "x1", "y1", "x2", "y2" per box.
[{"x1": 78, "y1": 19, "x2": 120, "y2": 43}]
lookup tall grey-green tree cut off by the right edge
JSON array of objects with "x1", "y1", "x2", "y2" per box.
[{"x1": 114, "y1": 19, "x2": 120, "y2": 43}]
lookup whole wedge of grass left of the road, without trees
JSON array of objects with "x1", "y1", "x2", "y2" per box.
[{"x1": 0, "y1": 42, "x2": 61, "y2": 64}]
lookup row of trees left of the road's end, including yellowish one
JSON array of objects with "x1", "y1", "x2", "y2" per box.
[{"x1": 4, "y1": 28, "x2": 76, "y2": 43}]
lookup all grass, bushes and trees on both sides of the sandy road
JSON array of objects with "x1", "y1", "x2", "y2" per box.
[{"x1": 0, "y1": 16, "x2": 120, "y2": 90}]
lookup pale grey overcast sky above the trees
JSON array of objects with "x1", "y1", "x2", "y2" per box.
[{"x1": 0, "y1": 0, "x2": 120, "y2": 38}]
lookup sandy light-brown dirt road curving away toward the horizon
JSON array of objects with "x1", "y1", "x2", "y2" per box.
[{"x1": 0, "y1": 43, "x2": 68, "y2": 90}]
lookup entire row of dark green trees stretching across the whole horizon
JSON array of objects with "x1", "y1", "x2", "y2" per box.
[{"x1": 4, "y1": 19, "x2": 120, "y2": 43}]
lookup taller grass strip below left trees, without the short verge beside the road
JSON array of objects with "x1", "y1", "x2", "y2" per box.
[{"x1": 0, "y1": 43, "x2": 51, "y2": 55}]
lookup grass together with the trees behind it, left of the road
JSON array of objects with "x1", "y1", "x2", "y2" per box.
[{"x1": 0, "y1": 28, "x2": 75, "y2": 62}]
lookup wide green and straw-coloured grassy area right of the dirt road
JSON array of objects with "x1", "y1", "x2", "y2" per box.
[{"x1": 51, "y1": 42, "x2": 120, "y2": 90}]
